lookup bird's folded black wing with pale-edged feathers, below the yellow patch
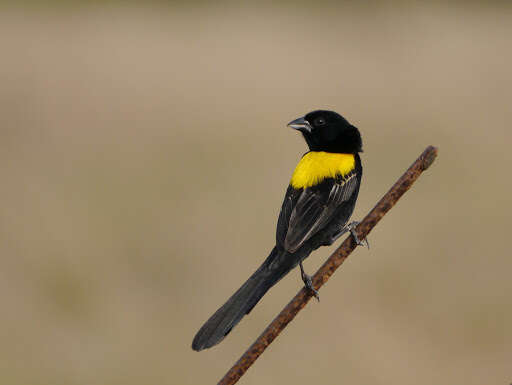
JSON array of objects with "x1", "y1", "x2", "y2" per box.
[{"x1": 276, "y1": 171, "x2": 359, "y2": 253}]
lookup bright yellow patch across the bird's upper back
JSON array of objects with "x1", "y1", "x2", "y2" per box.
[{"x1": 290, "y1": 151, "x2": 356, "y2": 189}]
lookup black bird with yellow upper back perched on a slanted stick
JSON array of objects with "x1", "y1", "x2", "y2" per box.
[{"x1": 192, "y1": 110, "x2": 369, "y2": 351}]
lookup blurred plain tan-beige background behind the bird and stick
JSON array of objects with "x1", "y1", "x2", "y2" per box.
[{"x1": 0, "y1": 1, "x2": 512, "y2": 385}]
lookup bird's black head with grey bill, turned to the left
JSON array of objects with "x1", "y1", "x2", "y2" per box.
[{"x1": 288, "y1": 110, "x2": 363, "y2": 154}]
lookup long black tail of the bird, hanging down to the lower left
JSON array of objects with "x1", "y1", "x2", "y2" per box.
[{"x1": 192, "y1": 246, "x2": 309, "y2": 351}]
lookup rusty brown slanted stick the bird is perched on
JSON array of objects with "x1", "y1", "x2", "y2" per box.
[{"x1": 219, "y1": 146, "x2": 437, "y2": 385}]
